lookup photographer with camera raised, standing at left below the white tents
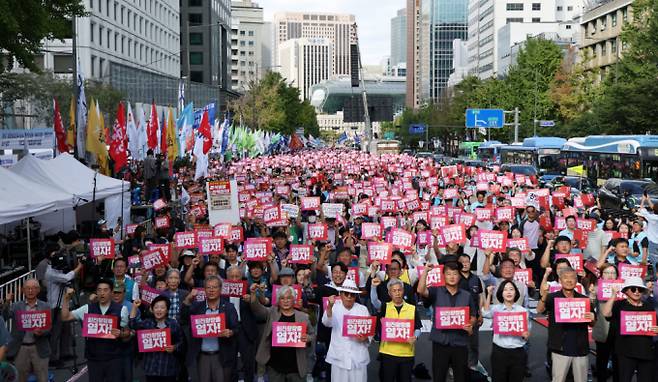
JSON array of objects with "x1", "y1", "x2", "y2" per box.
[{"x1": 45, "y1": 250, "x2": 83, "y2": 365}]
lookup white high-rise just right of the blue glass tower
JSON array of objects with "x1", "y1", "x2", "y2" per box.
[{"x1": 468, "y1": 0, "x2": 586, "y2": 78}]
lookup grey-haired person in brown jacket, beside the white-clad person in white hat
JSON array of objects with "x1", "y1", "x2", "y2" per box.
[{"x1": 251, "y1": 286, "x2": 315, "y2": 382}]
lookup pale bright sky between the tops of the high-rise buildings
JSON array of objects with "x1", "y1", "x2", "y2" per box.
[{"x1": 255, "y1": 0, "x2": 406, "y2": 65}]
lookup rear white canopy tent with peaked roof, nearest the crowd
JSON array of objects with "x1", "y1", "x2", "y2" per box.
[{"x1": 9, "y1": 154, "x2": 130, "y2": 228}]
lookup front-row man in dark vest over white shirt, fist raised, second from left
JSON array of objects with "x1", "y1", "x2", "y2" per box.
[{"x1": 61, "y1": 279, "x2": 130, "y2": 382}]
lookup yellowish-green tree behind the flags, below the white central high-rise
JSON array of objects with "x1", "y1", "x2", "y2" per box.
[{"x1": 229, "y1": 71, "x2": 320, "y2": 137}]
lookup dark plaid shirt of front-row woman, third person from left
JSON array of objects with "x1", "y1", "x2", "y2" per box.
[{"x1": 130, "y1": 318, "x2": 183, "y2": 377}]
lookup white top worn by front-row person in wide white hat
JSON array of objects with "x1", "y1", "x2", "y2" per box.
[{"x1": 322, "y1": 302, "x2": 370, "y2": 370}]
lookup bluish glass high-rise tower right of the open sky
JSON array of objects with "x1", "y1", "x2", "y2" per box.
[{"x1": 420, "y1": 0, "x2": 468, "y2": 100}]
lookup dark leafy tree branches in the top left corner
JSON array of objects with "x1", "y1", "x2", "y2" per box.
[{"x1": 0, "y1": 0, "x2": 85, "y2": 72}]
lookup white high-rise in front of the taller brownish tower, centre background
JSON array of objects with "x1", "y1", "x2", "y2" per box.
[{"x1": 278, "y1": 38, "x2": 335, "y2": 100}]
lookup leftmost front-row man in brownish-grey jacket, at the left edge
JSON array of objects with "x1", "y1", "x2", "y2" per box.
[{"x1": 3, "y1": 279, "x2": 50, "y2": 382}]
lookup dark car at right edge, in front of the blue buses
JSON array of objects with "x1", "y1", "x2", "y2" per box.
[{"x1": 599, "y1": 178, "x2": 658, "y2": 209}]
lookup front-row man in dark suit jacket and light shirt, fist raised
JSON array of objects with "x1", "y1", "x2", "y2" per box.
[{"x1": 182, "y1": 276, "x2": 239, "y2": 382}]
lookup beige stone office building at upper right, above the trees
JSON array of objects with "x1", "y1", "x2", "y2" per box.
[{"x1": 578, "y1": 0, "x2": 633, "y2": 80}]
